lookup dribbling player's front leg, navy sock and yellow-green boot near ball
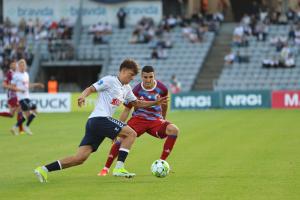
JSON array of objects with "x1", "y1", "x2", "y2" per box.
[{"x1": 113, "y1": 125, "x2": 136, "y2": 178}]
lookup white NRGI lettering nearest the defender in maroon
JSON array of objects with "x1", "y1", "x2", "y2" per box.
[{"x1": 174, "y1": 95, "x2": 212, "y2": 108}]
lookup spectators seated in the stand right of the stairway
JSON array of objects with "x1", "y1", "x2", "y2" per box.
[{"x1": 224, "y1": 3, "x2": 300, "y2": 68}]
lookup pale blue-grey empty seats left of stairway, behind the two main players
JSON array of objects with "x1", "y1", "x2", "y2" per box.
[{"x1": 103, "y1": 27, "x2": 214, "y2": 91}]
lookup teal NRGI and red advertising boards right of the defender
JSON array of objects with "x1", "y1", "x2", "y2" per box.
[{"x1": 171, "y1": 90, "x2": 300, "y2": 110}]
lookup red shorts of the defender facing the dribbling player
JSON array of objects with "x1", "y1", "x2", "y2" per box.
[{"x1": 127, "y1": 117, "x2": 171, "y2": 138}]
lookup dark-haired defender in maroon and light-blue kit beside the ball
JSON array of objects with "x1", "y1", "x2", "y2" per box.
[{"x1": 98, "y1": 66, "x2": 179, "y2": 176}]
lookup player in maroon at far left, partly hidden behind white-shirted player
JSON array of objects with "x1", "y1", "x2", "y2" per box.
[{"x1": 0, "y1": 61, "x2": 23, "y2": 131}]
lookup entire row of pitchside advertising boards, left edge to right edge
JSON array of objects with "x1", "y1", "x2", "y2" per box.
[{"x1": 0, "y1": 90, "x2": 300, "y2": 113}]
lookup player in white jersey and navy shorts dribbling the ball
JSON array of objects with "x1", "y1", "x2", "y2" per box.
[{"x1": 34, "y1": 59, "x2": 167, "y2": 182}]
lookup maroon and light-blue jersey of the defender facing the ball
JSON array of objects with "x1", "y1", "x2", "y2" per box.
[{"x1": 124, "y1": 81, "x2": 168, "y2": 120}]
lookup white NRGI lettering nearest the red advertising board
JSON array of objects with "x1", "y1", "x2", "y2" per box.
[{"x1": 225, "y1": 94, "x2": 263, "y2": 106}]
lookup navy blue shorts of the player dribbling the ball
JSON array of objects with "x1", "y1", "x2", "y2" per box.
[{"x1": 79, "y1": 117, "x2": 126, "y2": 152}]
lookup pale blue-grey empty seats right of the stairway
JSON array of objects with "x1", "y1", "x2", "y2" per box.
[{"x1": 214, "y1": 24, "x2": 300, "y2": 90}]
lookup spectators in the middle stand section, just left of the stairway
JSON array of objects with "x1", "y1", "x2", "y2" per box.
[{"x1": 129, "y1": 13, "x2": 224, "y2": 59}]
